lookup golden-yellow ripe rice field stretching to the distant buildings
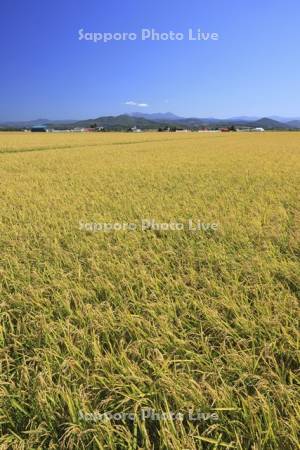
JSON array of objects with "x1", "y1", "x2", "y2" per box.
[{"x1": 0, "y1": 132, "x2": 300, "y2": 450}]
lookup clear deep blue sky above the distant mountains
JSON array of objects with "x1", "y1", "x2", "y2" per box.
[{"x1": 0, "y1": 0, "x2": 300, "y2": 121}]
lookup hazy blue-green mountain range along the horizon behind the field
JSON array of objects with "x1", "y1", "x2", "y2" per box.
[{"x1": 0, "y1": 112, "x2": 300, "y2": 130}]
